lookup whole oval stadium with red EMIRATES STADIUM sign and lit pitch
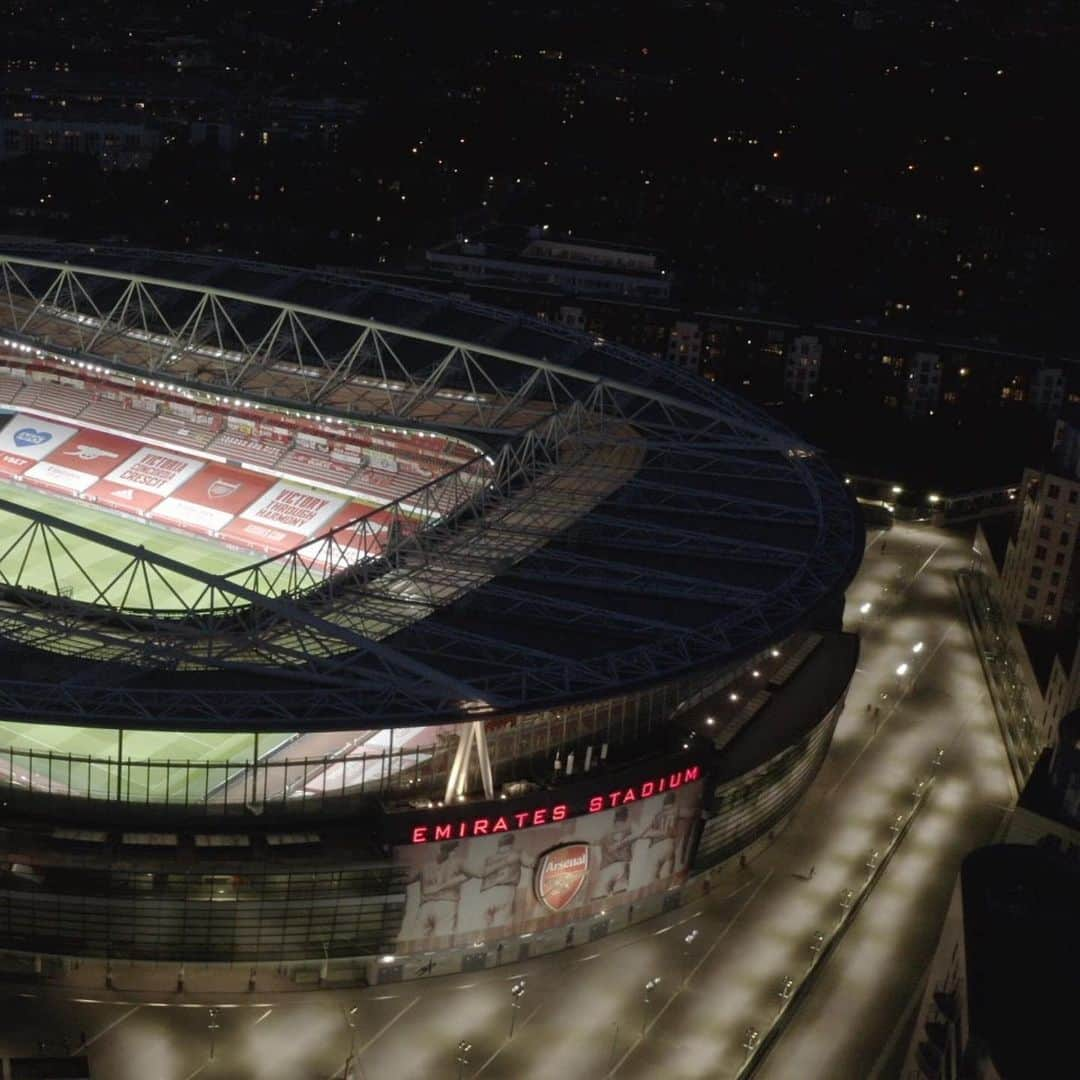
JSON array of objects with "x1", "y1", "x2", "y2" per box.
[{"x1": 0, "y1": 238, "x2": 863, "y2": 982}]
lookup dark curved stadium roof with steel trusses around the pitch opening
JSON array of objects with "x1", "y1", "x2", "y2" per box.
[{"x1": 0, "y1": 238, "x2": 862, "y2": 730}]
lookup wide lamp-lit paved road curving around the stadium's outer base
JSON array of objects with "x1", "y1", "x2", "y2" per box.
[{"x1": 0, "y1": 526, "x2": 1014, "y2": 1080}]
